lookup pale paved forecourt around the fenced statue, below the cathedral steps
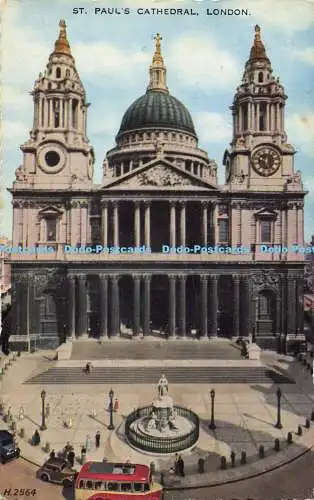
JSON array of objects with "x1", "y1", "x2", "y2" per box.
[{"x1": 2, "y1": 342, "x2": 314, "y2": 488}]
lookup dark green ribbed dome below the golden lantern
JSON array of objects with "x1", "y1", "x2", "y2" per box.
[{"x1": 118, "y1": 90, "x2": 196, "y2": 136}]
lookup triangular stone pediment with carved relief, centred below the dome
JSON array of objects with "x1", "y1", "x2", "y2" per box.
[{"x1": 102, "y1": 159, "x2": 218, "y2": 191}]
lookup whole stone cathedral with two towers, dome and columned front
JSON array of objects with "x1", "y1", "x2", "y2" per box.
[{"x1": 10, "y1": 21, "x2": 306, "y2": 351}]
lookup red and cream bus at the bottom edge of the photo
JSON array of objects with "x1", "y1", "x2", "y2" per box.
[{"x1": 75, "y1": 462, "x2": 163, "y2": 500}]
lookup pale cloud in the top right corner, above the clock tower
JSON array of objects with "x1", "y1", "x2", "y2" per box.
[{"x1": 226, "y1": 0, "x2": 314, "y2": 33}]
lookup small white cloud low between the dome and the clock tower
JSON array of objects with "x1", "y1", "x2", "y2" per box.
[{"x1": 194, "y1": 111, "x2": 232, "y2": 144}]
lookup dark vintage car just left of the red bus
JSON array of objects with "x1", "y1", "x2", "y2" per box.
[{"x1": 36, "y1": 458, "x2": 77, "y2": 487}]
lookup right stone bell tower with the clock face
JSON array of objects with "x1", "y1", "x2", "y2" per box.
[{"x1": 223, "y1": 26, "x2": 295, "y2": 191}]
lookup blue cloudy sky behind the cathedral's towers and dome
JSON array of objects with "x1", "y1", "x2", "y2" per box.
[{"x1": 0, "y1": 0, "x2": 314, "y2": 240}]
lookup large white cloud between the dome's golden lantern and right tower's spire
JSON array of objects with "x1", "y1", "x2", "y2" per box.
[{"x1": 167, "y1": 34, "x2": 241, "y2": 91}]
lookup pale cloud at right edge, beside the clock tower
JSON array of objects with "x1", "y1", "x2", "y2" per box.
[{"x1": 286, "y1": 112, "x2": 314, "y2": 156}]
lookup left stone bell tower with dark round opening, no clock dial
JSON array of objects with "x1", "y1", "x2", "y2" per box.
[{"x1": 13, "y1": 20, "x2": 94, "y2": 189}]
